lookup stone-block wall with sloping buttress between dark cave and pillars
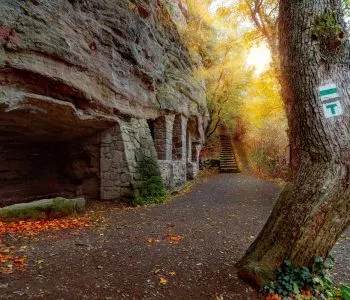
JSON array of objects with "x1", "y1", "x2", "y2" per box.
[{"x1": 101, "y1": 118, "x2": 157, "y2": 200}]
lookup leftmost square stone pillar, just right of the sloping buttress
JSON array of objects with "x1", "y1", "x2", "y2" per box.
[{"x1": 154, "y1": 115, "x2": 175, "y2": 160}]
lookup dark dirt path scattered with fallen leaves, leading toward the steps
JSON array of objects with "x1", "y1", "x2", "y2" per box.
[{"x1": 0, "y1": 174, "x2": 350, "y2": 300}]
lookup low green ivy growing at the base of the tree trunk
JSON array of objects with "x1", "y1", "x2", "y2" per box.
[{"x1": 262, "y1": 257, "x2": 350, "y2": 300}]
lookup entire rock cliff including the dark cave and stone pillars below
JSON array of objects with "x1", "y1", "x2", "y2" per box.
[{"x1": 0, "y1": 0, "x2": 206, "y2": 206}]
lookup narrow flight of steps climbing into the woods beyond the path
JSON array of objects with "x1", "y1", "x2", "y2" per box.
[{"x1": 220, "y1": 134, "x2": 240, "y2": 173}]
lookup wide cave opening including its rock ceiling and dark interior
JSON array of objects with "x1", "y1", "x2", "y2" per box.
[{"x1": 0, "y1": 99, "x2": 115, "y2": 207}]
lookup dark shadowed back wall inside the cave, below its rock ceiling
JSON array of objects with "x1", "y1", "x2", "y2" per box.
[{"x1": 0, "y1": 136, "x2": 100, "y2": 207}]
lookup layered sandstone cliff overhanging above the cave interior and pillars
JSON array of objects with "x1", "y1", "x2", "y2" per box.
[{"x1": 0, "y1": 0, "x2": 205, "y2": 140}]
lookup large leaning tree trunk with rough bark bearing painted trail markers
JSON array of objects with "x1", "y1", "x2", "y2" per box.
[{"x1": 239, "y1": 0, "x2": 350, "y2": 286}]
